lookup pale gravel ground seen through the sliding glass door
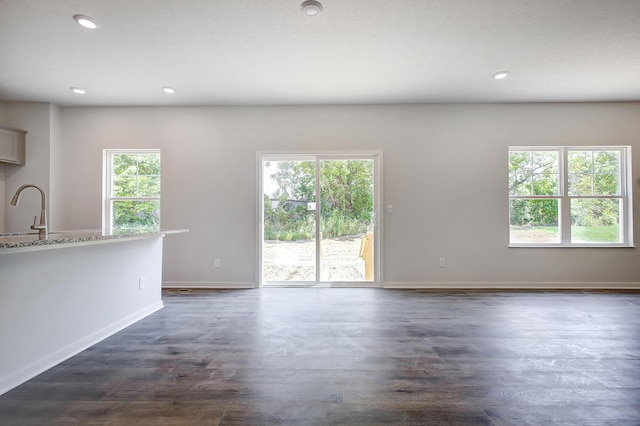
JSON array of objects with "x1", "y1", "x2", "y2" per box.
[{"x1": 262, "y1": 235, "x2": 365, "y2": 282}]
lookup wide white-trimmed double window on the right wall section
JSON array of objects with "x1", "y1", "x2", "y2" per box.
[{"x1": 509, "y1": 146, "x2": 633, "y2": 247}]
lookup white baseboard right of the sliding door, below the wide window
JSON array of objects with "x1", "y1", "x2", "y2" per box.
[{"x1": 382, "y1": 281, "x2": 640, "y2": 290}]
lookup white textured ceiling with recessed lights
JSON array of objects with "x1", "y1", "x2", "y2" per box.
[{"x1": 0, "y1": 0, "x2": 640, "y2": 106}]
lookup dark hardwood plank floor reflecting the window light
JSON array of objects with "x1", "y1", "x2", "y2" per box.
[{"x1": 0, "y1": 288, "x2": 640, "y2": 425}]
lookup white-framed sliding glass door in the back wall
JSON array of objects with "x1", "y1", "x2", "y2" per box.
[{"x1": 260, "y1": 154, "x2": 379, "y2": 286}]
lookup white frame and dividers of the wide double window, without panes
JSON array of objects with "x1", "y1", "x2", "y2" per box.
[{"x1": 507, "y1": 145, "x2": 634, "y2": 247}]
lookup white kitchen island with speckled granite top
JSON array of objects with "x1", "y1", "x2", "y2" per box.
[{"x1": 0, "y1": 230, "x2": 187, "y2": 395}]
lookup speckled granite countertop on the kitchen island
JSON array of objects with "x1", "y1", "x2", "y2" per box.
[{"x1": 0, "y1": 229, "x2": 189, "y2": 254}]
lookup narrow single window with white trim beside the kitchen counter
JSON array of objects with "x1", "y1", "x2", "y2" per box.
[{"x1": 102, "y1": 149, "x2": 160, "y2": 232}]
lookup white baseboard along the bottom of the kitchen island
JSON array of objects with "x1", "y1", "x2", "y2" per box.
[{"x1": 0, "y1": 301, "x2": 164, "y2": 395}]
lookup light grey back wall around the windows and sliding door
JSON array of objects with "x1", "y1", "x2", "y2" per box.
[{"x1": 60, "y1": 103, "x2": 640, "y2": 287}]
